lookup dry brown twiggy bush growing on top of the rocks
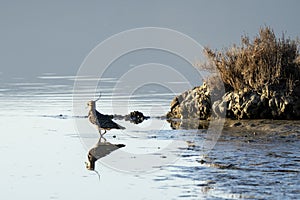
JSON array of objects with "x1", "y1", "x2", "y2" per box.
[{"x1": 204, "y1": 27, "x2": 300, "y2": 95}]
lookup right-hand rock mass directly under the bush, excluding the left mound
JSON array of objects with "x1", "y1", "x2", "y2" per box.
[{"x1": 212, "y1": 90, "x2": 300, "y2": 119}]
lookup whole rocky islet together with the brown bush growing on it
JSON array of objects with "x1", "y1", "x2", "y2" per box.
[{"x1": 167, "y1": 27, "x2": 300, "y2": 119}]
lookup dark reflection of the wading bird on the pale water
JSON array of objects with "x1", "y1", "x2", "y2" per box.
[{"x1": 85, "y1": 137, "x2": 125, "y2": 171}]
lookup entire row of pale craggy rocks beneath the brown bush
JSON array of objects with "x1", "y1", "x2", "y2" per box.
[{"x1": 167, "y1": 83, "x2": 300, "y2": 119}]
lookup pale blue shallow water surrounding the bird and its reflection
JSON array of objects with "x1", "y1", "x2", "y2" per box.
[{"x1": 0, "y1": 75, "x2": 300, "y2": 199}]
